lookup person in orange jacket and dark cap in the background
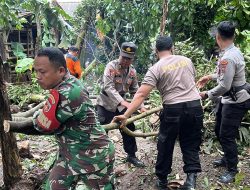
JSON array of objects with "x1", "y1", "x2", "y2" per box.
[{"x1": 66, "y1": 46, "x2": 82, "y2": 79}]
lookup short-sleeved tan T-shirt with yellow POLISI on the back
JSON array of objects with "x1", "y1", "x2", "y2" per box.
[{"x1": 142, "y1": 55, "x2": 200, "y2": 104}]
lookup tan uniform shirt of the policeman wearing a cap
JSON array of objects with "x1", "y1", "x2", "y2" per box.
[{"x1": 97, "y1": 59, "x2": 139, "y2": 112}]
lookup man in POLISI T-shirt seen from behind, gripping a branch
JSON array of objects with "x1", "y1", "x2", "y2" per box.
[{"x1": 114, "y1": 36, "x2": 203, "y2": 190}]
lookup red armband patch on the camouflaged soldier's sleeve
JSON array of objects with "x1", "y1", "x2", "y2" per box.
[{"x1": 37, "y1": 89, "x2": 60, "y2": 131}]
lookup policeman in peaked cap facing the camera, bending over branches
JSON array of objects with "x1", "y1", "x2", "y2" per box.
[{"x1": 97, "y1": 42, "x2": 145, "y2": 167}]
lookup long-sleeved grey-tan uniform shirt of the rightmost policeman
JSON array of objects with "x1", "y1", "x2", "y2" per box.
[{"x1": 208, "y1": 44, "x2": 250, "y2": 104}]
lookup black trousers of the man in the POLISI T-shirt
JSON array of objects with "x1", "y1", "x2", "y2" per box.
[{"x1": 155, "y1": 100, "x2": 203, "y2": 179}]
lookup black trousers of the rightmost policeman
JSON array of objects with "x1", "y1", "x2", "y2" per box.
[{"x1": 215, "y1": 99, "x2": 250, "y2": 171}]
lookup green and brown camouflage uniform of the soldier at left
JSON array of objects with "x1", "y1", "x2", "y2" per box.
[{"x1": 34, "y1": 74, "x2": 114, "y2": 190}]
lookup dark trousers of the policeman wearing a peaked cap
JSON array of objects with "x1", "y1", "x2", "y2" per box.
[{"x1": 96, "y1": 105, "x2": 137, "y2": 156}]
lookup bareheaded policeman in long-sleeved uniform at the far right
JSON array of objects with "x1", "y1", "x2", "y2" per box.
[{"x1": 197, "y1": 21, "x2": 250, "y2": 183}]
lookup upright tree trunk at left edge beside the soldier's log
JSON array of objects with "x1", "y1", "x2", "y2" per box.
[{"x1": 0, "y1": 57, "x2": 22, "y2": 189}]
